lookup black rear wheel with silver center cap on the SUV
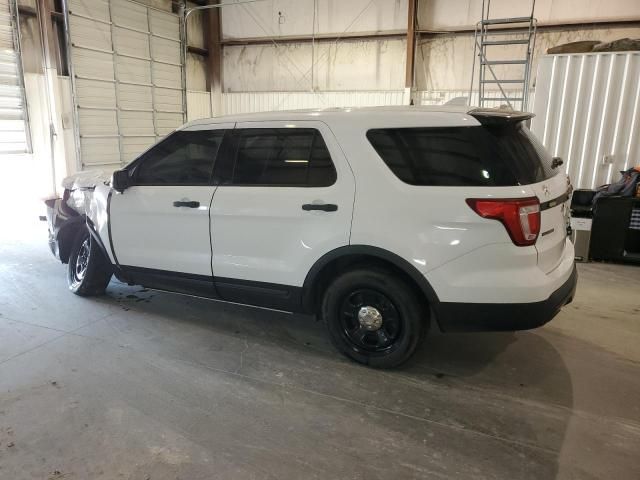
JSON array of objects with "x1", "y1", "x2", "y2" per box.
[{"x1": 320, "y1": 268, "x2": 428, "y2": 368}]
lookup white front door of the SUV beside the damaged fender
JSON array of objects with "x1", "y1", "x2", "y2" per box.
[{"x1": 109, "y1": 124, "x2": 233, "y2": 294}]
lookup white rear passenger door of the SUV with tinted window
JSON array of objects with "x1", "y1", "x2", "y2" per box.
[{"x1": 211, "y1": 121, "x2": 355, "y2": 309}]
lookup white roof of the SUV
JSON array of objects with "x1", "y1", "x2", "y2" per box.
[{"x1": 183, "y1": 105, "x2": 531, "y2": 128}]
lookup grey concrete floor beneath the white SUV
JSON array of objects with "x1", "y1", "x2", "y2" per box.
[{"x1": 0, "y1": 212, "x2": 640, "y2": 480}]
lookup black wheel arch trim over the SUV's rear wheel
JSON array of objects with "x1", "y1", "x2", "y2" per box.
[{"x1": 302, "y1": 245, "x2": 439, "y2": 320}]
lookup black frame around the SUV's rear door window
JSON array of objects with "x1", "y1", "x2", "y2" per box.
[{"x1": 212, "y1": 126, "x2": 338, "y2": 188}]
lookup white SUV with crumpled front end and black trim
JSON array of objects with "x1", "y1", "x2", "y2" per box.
[{"x1": 47, "y1": 107, "x2": 577, "y2": 367}]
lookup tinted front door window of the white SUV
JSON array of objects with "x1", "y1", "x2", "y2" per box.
[{"x1": 134, "y1": 130, "x2": 225, "y2": 185}]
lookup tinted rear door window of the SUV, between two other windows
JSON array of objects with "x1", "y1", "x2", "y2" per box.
[{"x1": 229, "y1": 128, "x2": 336, "y2": 187}]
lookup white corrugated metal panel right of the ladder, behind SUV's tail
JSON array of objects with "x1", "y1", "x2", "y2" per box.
[{"x1": 532, "y1": 52, "x2": 640, "y2": 188}]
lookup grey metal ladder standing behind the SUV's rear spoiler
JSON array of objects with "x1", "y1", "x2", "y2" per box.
[{"x1": 469, "y1": 0, "x2": 537, "y2": 111}]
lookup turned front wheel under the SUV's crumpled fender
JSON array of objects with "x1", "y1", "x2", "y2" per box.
[{"x1": 67, "y1": 228, "x2": 113, "y2": 297}]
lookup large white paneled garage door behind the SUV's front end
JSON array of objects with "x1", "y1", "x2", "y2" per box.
[{"x1": 69, "y1": 0, "x2": 185, "y2": 169}]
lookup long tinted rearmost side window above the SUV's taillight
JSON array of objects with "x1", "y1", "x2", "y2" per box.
[{"x1": 367, "y1": 124, "x2": 557, "y2": 187}]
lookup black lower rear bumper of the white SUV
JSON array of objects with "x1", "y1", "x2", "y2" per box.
[{"x1": 435, "y1": 265, "x2": 578, "y2": 332}]
